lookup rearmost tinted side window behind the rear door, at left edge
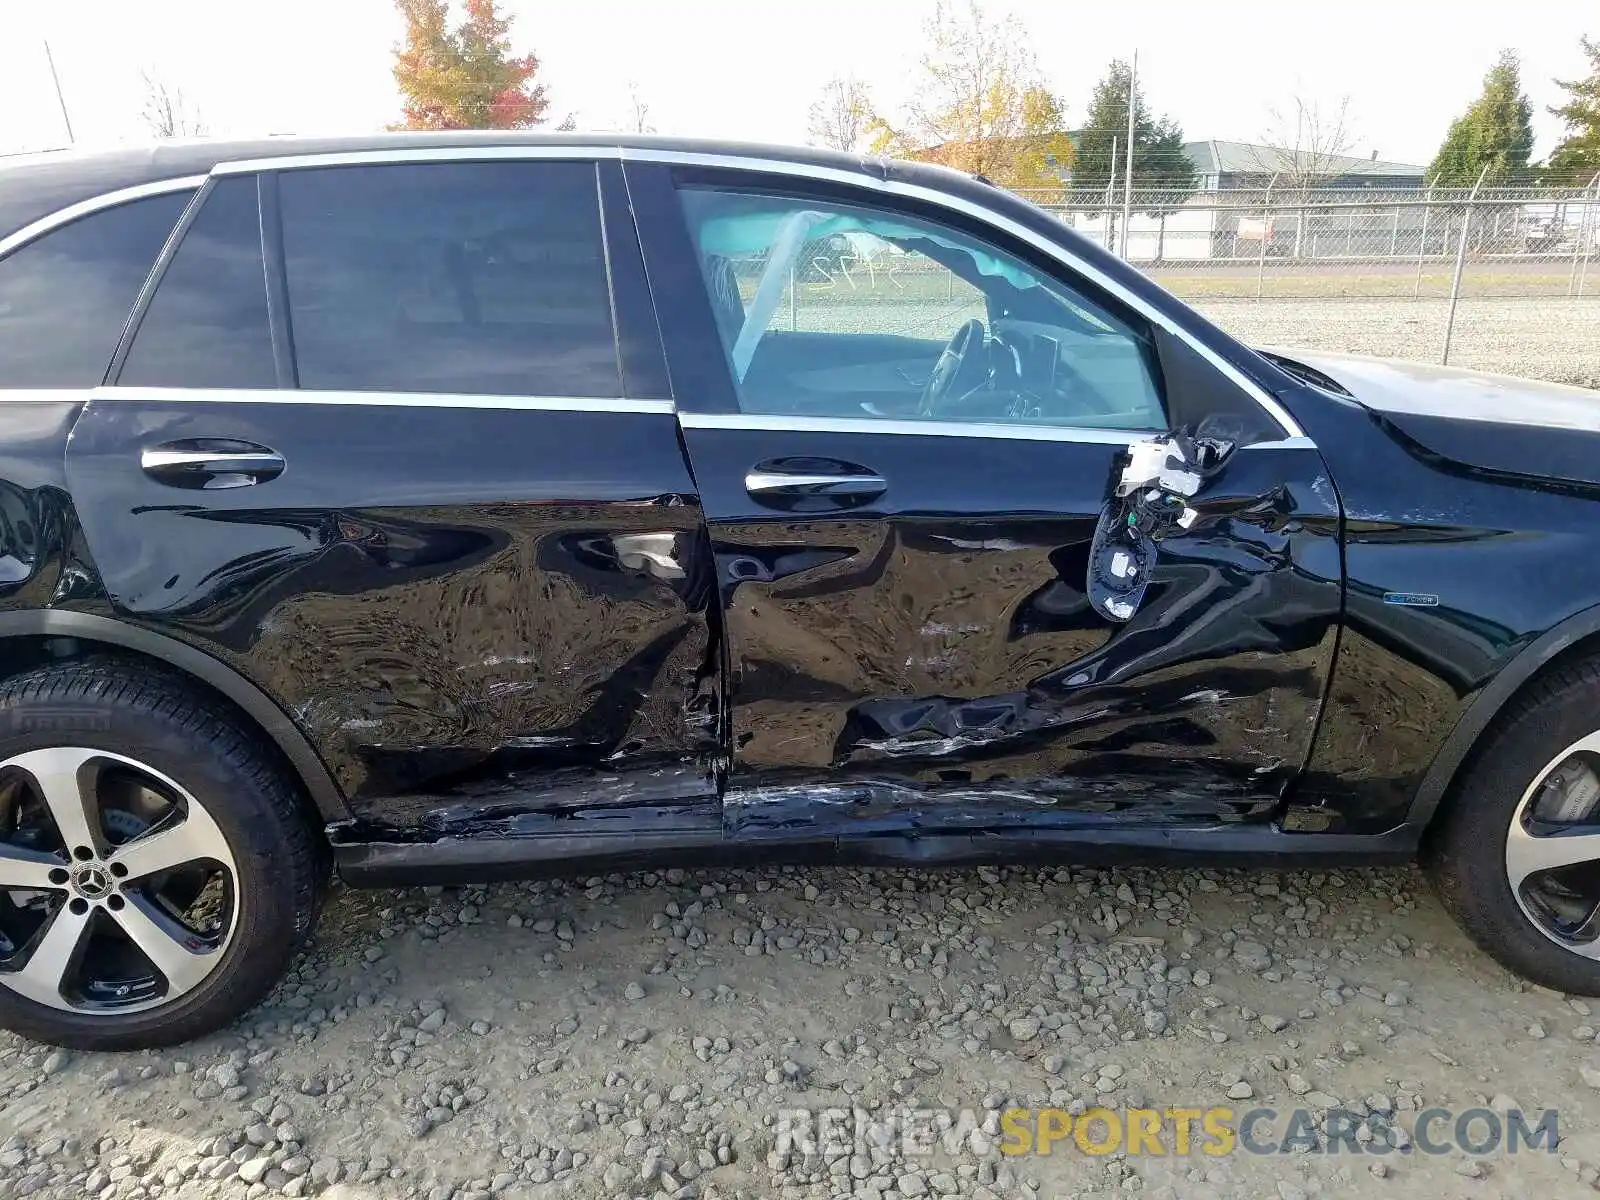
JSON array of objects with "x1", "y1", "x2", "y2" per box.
[{"x1": 0, "y1": 190, "x2": 194, "y2": 389}]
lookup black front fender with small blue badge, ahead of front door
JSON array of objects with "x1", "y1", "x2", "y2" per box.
[{"x1": 1283, "y1": 376, "x2": 1600, "y2": 832}]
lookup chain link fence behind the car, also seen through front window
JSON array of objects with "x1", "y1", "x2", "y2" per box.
[{"x1": 726, "y1": 182, "x2": 1600, "y2": 387}]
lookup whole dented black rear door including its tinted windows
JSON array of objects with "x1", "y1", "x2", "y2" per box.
[{"x1": 67, "y1": 158, "x2": 720, "y2": 837}]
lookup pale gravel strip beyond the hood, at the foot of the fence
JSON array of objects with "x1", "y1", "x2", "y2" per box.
[{"x1": 1194, "y1": 298, "x2": 1600, "y2": 387}]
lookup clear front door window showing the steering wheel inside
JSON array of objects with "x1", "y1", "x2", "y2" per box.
[{"x1": 680, "y1": 187, "x2": 1166, "y2": 430}]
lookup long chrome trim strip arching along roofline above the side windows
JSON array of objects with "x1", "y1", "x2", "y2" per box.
[{"x1": 200, "y1": 144, "x2": 1304, "y2": 438}]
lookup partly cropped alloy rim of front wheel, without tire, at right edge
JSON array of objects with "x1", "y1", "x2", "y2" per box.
[{"x1": 1506, "y1": 733, "x2": 1600, "y2": 958}]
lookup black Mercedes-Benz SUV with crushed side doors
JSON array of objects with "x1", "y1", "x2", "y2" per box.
[{"x1": 0, "y1": 134, "x2": 1600, "y2": 1048}]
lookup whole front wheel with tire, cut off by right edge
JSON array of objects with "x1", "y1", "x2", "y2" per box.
[{"x1": 1424, "y1": 661, "x2": 1600, "y2": 995}]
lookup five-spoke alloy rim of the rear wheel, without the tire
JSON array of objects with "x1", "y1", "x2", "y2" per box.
[{"x1": 0, "y1": 747, "x2": 238, "y2": 1014}]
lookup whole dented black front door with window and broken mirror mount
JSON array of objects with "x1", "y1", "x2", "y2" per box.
[{"x1": 629, "y1": 165, "x2": 1341, "y2": 840}]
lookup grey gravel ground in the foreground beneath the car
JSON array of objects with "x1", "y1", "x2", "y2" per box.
[{"x1": 0, "y1": 869, "x2": 1600, "y2": 1200}]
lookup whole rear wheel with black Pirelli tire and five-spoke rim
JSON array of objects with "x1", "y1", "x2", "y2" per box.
[{"x1": 0, "y1": 659, "x2": 326, "y2": 1050}]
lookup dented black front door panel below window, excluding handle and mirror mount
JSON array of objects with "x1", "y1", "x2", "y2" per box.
[{"x1": 688, "y1": 419, "x2": 1339, "y2": 819}]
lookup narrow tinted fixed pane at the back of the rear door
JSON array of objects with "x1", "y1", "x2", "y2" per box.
[{"x1": 117, "y1": 176, "x2": 277, "y2": 387}]
